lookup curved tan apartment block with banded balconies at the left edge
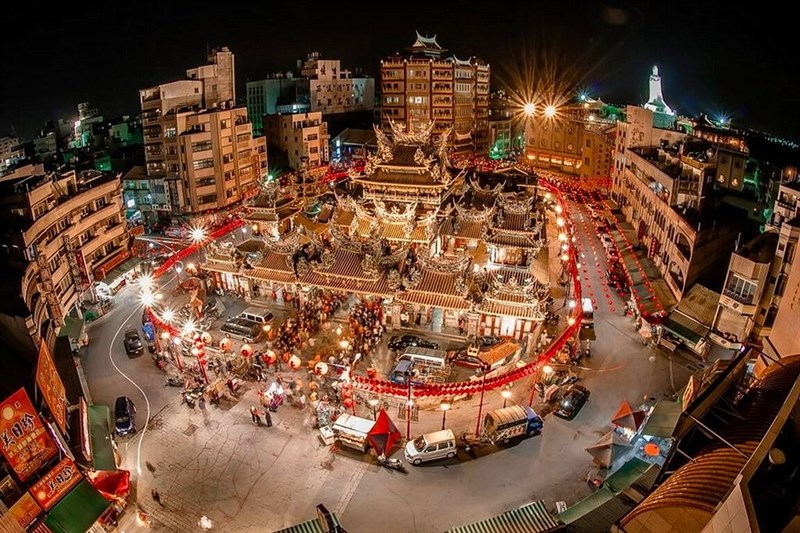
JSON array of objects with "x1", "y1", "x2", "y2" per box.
[{"x1": 0, "y1": 165, "x2": 128, "y2": 343}]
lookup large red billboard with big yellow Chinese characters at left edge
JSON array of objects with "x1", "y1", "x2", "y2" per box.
[{"x1": 0, "y1": 388, "x2": 58, "y2": 481}]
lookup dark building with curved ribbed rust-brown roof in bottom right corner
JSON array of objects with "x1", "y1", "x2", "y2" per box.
[{"x1": 620, "y1": 348, "x2": 800, "y2": 533}]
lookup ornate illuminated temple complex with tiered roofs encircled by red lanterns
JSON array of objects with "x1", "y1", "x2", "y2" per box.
[{"x1": 204, "y1": 122, "x2": 551, "y2": 339}]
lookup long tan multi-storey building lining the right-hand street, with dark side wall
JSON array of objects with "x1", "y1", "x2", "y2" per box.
[{"x1": 611, "y1": 106, "x2": 747, "y2": 301}]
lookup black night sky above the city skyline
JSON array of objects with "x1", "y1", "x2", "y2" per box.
[{"x1": 0, "y1": 0, "x2": 800, "y2": 140}]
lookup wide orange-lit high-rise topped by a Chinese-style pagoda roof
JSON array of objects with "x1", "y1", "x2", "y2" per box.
[{"x1": 380, "y1": 33, "x2": 491, "y2": 152}]
